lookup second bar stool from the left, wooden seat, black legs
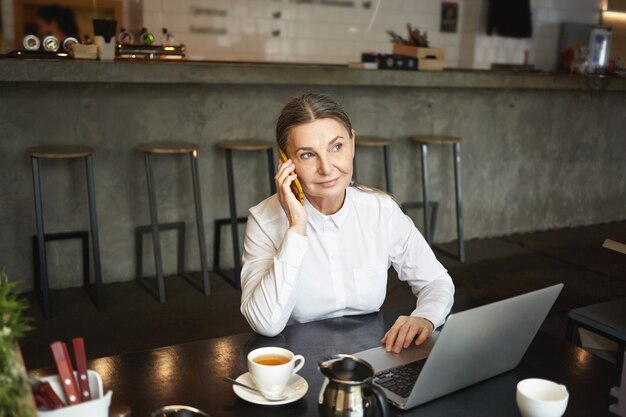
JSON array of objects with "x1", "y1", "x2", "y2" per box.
[{"x1": 135, "y1": 142, "x2": 211, "y2": 303}]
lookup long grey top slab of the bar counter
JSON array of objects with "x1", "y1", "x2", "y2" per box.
[{"x1": 0, "y1": 59, "x2": 626, "y2": 91}]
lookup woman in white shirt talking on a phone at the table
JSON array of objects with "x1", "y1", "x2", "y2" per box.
[{"x1": 241, "y1": 94, "x2": 454, "y2": 352}]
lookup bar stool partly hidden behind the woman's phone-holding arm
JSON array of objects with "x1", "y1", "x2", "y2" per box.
[{"x1": 213, "y1": 139, "x2": 276, "y2": 289}]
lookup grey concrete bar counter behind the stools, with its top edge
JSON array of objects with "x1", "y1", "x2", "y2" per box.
[{"x1": 0, "y1": 60, "x2": 626, "y2": 288}]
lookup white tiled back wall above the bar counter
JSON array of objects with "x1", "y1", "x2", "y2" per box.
[{"x1": 0, "y1": 0, "x2": 602, "y2": 69}]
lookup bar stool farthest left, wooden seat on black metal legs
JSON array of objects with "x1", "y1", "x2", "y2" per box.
[{"x1": 26, "y1": 145, "x2": 102, "y2": 319}]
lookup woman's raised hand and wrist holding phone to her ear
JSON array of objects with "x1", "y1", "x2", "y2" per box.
[{"x1": 274, "y1": 159, "x2": 307, "y2": 235}]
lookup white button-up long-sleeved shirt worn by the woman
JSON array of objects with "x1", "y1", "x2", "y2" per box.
[{"x1": 241, "y1": 187, "x2": 454, "y2": 336}]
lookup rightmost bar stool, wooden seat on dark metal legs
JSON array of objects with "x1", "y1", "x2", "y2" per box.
[{"x1": 406, "y1": 135, "x2": 465, "y2": 262}]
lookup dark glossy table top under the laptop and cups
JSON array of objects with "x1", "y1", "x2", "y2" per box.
[{"x1": 31, "y1": 310, "x2": 618, "y2": 417}]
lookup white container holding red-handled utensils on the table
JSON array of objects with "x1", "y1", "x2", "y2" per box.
[{"x1": 37, "y1": 370, "x2": 113, "y2": 417}]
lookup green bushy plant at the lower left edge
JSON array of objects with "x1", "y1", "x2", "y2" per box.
[{"x1": 0, "y1": 269, "x2": 35, "y2": 417}]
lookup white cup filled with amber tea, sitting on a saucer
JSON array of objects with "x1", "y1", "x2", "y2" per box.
[{"x1": 248, "y1": 347, "x2": 304, "y2": 399}]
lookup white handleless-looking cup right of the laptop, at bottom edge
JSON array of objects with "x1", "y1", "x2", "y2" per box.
[{"x1": 517, "y1": 378, "x2": 569, "y2": 417}]
